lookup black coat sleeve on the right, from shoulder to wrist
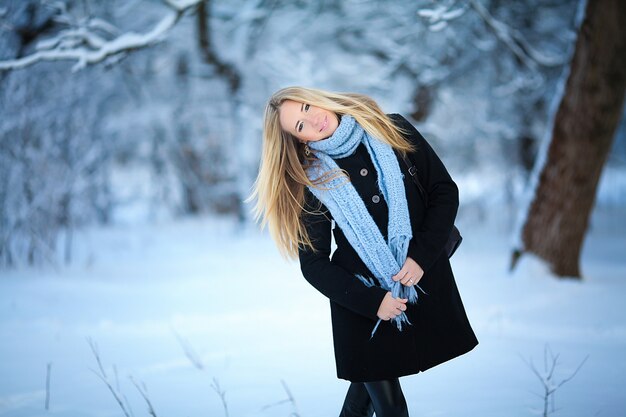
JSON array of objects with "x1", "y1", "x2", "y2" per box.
[{"x1": 390, "y1": 114, "x2": 459, "y2": 272}]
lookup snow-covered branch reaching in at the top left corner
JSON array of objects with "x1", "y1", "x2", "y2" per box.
[{"x1": 0, "y1": 0, "x2": 200, "y2": 71}]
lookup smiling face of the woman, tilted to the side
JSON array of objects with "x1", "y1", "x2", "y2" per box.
[{"x1": 279, "y1": 100, "x2": 339, "y2": 142}]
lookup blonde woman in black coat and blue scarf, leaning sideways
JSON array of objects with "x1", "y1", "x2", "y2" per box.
[{"x1": 253, "y1": 87, "x2": 478, "y2": 417}]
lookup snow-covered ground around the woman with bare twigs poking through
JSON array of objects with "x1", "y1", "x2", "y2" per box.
[{"x1": 0, "y1": 208, "x2": 626, "y2": 417}]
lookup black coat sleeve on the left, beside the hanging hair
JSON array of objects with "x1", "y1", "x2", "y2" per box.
[{"x1": 298, "y1": 189, "x2": 387, "y2": 320}]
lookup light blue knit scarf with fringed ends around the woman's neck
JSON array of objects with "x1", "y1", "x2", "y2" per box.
[{"x1": 307, "y1": 115, "x2": 418, "y2": 336}]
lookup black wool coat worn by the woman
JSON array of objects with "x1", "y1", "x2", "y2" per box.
[{"x1": 299, "y1": 114, "x2": 478, "y2": 382}]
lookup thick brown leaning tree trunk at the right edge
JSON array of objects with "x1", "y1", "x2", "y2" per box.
[{"x1": 512, "y1": 0, "x2": 626, "y2": 279}]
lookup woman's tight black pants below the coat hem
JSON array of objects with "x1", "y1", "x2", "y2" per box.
[{"x1": 339, "y1": 378, "x2": 409, "y2": 417}]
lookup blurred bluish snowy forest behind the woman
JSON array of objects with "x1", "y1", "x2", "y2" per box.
[{"x1": 0, "y1": 0, "x2": 626, "y2": 268}]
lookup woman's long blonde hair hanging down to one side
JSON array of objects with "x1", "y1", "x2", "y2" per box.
[{"x1": 247, "y1": 87, "x2": 413, "y2": 258}]
